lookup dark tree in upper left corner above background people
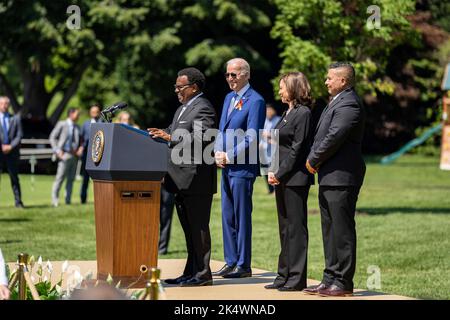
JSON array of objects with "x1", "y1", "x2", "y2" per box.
[{"x1": 0, "y1": 0, "x2": 147, "y2": 129}]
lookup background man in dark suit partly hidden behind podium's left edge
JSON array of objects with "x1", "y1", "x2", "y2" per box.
[{"x1": 80, "y1": 104, "x2": 102, "y2": 204}]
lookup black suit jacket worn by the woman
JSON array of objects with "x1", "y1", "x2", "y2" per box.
[{"x1": 270, "y1": 105, "x2": 314, "y2": 186}]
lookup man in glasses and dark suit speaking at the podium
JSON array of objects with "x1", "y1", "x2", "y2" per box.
[{"x1": 148, "y1": 68, "x2": 217, "y2": 286}]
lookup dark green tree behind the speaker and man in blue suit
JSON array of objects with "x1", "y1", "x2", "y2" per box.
[{"x1": 112, "y1": 0, "x2": 278, "y2": 126}]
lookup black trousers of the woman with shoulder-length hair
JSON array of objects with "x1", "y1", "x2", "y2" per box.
[{"x1": 274, "y1": 184, "x2": 309, "y2": 290}]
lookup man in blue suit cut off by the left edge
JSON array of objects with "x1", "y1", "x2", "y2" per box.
[{"x1": 0, "y1": 97, "x2": 24, "y2": 208}]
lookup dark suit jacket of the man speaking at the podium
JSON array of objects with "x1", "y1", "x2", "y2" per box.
[{"x1": 165, "y1": 95, "x2": 217, "y2": 194}]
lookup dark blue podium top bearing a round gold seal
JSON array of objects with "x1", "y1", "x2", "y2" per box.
[{"x1": 86, "y1": 123, "x2": 168, "y2": 181}]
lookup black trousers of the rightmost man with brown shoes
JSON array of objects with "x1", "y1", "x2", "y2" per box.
[{"x1": 319, "y1": 186, "x2": 360, "y2": 290}]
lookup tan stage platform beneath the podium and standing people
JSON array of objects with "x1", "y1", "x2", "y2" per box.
[{"x1": 9, "y1": 259, "x2": 412, "y2": 300}]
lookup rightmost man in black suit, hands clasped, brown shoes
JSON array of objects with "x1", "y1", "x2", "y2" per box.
[{"x1": 304, "y1": 62, "x2": 366, "y2": 296}]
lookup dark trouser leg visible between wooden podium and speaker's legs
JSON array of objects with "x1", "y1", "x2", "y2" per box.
[{"x1": 158, "y1": 185, "x2": 175, "y2": 254}]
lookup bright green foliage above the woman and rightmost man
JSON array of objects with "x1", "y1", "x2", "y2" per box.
[{"x1": 271, "y1": 0, "x2": 418, "y2": 97}]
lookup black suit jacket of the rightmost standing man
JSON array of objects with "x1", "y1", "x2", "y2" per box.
[{"x1": 308, "y1": 88, "x2": 366, "y2": 186}]
